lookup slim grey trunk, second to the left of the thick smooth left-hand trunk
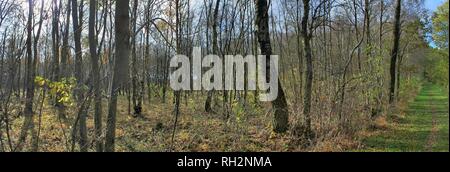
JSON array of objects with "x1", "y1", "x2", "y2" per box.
[{"x1": 72, "y1": 0, "x2": 88, "y2": 152}]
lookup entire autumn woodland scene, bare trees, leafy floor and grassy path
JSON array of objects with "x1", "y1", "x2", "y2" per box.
[{"x1": 0, "y1": 0, "x2": 449, "y2": 152}]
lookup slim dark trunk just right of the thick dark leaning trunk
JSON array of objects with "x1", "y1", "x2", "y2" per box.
[{"x1": 302, "y1": 0, "x2": 313, "y2": 137}]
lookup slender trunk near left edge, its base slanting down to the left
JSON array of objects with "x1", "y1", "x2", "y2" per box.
[{"x1": 16, "y1": 0, "x2": 36, "y2": 151}]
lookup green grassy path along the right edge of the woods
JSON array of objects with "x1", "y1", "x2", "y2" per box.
[{"x1": 362, "y1": 84, "x2": 449, "y2": 152}]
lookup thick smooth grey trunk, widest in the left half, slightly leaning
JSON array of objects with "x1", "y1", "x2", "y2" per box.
[{"x1": 105, "y1": 0, "x2": 130, "y2": 152}]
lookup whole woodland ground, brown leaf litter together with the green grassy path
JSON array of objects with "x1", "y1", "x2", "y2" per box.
[{"x1": 6, "y1": 84, "x2": 449, "y2": 152}]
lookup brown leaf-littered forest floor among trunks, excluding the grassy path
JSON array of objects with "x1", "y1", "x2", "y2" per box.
[{"x1": 7, "y1": 92, "x2": 297, "y2": 152}]
